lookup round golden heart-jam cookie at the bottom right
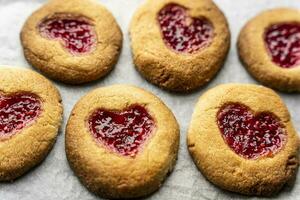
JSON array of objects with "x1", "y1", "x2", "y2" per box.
[{"x1": 187, "y1": 84, "x2": 299, "y2": 196}]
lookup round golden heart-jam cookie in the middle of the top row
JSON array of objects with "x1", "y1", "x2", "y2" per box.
[{"x1": 130, "y1": 0, "x2": 230, "y2": 92}]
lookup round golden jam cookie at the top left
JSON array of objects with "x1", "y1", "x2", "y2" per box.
[{"x1": 21, "y1": 0, "x2": 122, "y2": 84}]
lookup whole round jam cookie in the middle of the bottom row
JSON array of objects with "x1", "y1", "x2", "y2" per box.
[{"x1": 66, "y1": 85, "x2": 179, "y2": 199}]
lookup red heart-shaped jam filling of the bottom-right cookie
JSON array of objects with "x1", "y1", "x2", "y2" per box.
[{"x1": 217, "y1": 103, "x2": 287, "y2": 159}]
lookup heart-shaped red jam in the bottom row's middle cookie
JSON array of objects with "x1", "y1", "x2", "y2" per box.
[{"x1": 88, "y1": 105, "x2": 155, "y2": 156}]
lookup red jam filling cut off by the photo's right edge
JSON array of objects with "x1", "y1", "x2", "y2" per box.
[{"x1": 265, "y1": 23, "x2": 300, "y2": 68}]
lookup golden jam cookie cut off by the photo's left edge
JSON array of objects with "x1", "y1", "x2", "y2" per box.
[{"x1": 0, "y1": 67, "x2": 62, "y2": 181}]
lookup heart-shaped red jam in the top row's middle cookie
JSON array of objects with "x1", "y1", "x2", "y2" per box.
[{"x1": 157, "y1": 3, "x2": 213, "y2": 53}]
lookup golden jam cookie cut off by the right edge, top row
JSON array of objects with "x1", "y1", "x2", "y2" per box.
[{"x1": 238, "y1": 8, "x2": 300, "y2": 92}]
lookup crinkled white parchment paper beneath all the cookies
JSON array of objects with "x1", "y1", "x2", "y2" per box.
[{"x1": 0, "y1": 0, "x2": 300, "y2": 200}]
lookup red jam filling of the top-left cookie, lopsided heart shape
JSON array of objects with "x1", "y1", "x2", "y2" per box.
[{"x1": 39, "y1": 14, "x2": 96, "y2": 55}]
